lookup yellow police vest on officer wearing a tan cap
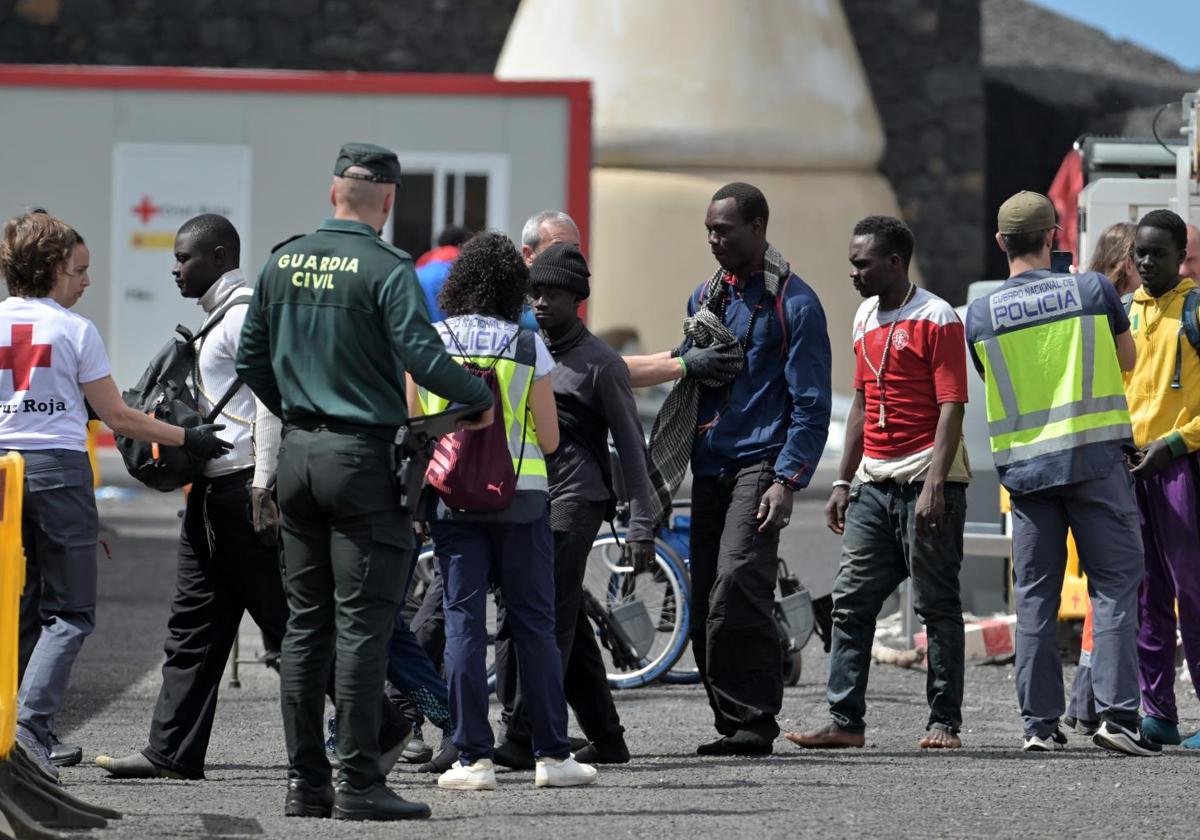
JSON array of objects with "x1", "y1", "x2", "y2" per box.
[{"x1": 968, "y1": 275, "x2": 1133, "y2": 492}]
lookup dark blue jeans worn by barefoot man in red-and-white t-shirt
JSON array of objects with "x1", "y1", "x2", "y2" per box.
[{"x1": 828, "y1": 481, "x2": 967, "y2": 733}]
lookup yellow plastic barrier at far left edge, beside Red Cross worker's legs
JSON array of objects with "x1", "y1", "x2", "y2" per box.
[{"x1": 0, "y1": 452, "x2": 25, "y2": 761}]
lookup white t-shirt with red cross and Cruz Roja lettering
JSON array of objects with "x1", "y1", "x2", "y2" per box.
[{"x1": 0, "y1": 298, "x2": 112, "y2": 451}]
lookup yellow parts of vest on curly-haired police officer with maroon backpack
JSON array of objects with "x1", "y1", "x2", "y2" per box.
[{"x1": 418, "y1": 322, "x2": 550, "y2": 493}]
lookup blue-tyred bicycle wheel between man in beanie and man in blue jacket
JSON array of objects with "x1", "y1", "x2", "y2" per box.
[{"x1": 583, "y1": 534, "x2": 690, "y2": 689}]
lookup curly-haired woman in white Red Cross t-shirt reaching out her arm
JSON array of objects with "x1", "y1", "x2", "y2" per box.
[{"x1": 0, "y1": 210, "x2": 229, "y2": 779}]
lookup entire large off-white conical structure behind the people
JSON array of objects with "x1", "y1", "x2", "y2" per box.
[{"x1": 496, "y1": 0, "x2": 898, "y2": 392}]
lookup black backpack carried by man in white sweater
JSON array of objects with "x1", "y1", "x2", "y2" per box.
[{"x1": 116, "y1": 295, "x2": 250, "y2": 493}]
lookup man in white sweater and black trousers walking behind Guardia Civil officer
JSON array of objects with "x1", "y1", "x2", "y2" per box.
[{"x1": 96, "y1": 214, "x2": 288, "y2": 779}]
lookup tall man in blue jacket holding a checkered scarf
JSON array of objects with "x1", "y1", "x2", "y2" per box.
[{"x1": 625, "y1": 182, "x2": 830, "y2": 755}]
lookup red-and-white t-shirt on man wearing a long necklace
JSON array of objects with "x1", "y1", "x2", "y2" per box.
[{"x1": 853, "y1": 288, "x2": 967, "y2": 480}]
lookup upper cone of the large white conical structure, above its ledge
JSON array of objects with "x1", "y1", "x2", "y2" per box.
[{"x1": 496, "y1": 0, "x2": 883, "y2": 169}]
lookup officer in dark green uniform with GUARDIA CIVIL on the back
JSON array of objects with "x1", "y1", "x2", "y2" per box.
[{"x1": 238, "y1": 143, "x2": 492, "y2": 820}]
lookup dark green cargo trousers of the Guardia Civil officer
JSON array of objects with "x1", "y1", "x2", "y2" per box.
[{"x1": 277, "y1": 421, "x2": 414, "y2": 788}]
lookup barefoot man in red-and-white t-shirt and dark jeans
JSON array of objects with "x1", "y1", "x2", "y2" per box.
[{"x1": 786, "y1": 216, "x2": 971, "y2": 749}]
